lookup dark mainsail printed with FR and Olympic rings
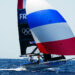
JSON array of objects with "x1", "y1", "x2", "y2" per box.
[{"x1": 17, "y1": 0, "x2": 37, "y2": 55}]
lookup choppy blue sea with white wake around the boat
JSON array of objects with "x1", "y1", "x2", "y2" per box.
[{"x1": 0, "y1": 59, "x2": 75, "y2": 75}]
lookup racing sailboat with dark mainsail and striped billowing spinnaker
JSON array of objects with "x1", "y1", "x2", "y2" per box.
[{"x1": 18, "y1": 0, "x2": 75, "y2": 70}]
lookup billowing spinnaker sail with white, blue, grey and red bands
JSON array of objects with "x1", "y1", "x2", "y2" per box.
[{"x1": 26, "y1": 0, "x2": 75, "y2": 55}]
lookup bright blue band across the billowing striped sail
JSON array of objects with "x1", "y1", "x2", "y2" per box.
[{"x1": 27, "y1": 9, "x2": 66, "y2": 28}]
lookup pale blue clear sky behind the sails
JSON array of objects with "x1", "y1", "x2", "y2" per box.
[{"x1": 0, "y1": 0, "x2": 75, "y2": 58}]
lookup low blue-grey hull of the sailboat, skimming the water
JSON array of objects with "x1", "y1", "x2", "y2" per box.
[{"x1": 22, "y1": 61, "x2": 66, "y2": 70}]
